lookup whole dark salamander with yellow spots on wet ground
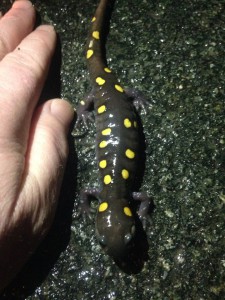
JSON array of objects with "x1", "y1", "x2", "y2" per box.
[{"x1": 74, "y1": 0, "x2": 149, "y2": 258}]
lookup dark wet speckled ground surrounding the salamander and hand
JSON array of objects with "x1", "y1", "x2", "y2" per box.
[{"x1": 0, "y1": 0, "x2": 225, "y2": 300}]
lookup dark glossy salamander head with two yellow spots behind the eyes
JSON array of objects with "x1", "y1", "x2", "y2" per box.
[{"x1": 96, "y1": 199, "x2": 135, "y2": 259}]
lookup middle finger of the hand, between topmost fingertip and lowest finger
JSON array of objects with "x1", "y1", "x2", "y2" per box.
[{"x1": 0, "y1": 25, "x2": 56, "y2": 149}]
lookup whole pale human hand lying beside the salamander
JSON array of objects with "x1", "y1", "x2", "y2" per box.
[{"x1": 0, "y1": 0, "x2": 73, "y2": 291}]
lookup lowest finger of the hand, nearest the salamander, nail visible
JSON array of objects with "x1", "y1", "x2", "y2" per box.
[{"x1": 17, "y1": 99, "x2": 74, "y2": 234}]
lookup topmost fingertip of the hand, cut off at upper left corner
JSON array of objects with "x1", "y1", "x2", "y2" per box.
[{"x1": 0, "y1": 0, "x2": 35, "y2": 60}]
